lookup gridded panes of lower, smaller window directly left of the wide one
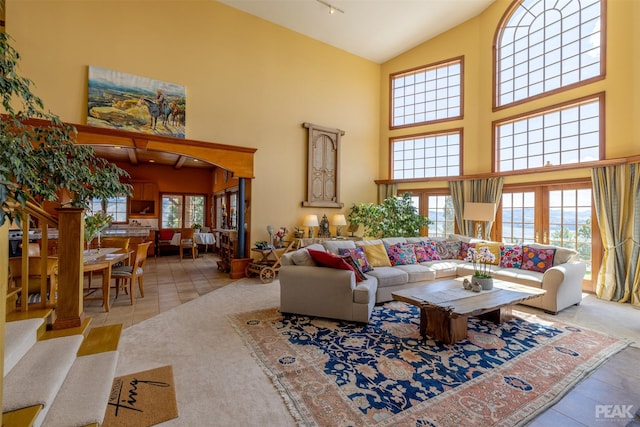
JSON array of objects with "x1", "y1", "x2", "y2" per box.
[{"x1": 391, "y1": 131, "x2": 462, "y2": 179}]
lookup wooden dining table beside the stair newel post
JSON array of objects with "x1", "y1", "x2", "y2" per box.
[{"x1": 83, "y1": 248, "x2": 133, "y2": 312}]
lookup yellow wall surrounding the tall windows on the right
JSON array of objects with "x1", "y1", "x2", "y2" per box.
[{"x1": 378, "y1": 0, "x2": 640, "y2": 188}]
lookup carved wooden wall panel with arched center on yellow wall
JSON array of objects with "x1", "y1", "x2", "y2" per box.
[{"x1": 302, "y1": 123, "x2": 344, "y2": 208}]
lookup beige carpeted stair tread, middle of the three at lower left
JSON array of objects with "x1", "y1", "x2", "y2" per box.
[{"x1": 2, "y1": 335, "x2": 83, "y2": 425}]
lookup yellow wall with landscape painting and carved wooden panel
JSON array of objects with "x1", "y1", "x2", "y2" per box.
[{"x1": 6, "y1": 0, "x2": 380, "y2": 240}]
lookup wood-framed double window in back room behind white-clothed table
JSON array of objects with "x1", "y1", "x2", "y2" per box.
[{"x1": 162, "y1": 194, "x2": 205, "y2": 228}]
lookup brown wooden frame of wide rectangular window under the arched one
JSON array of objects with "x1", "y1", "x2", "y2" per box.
[{"x1": 491, "y1": 92, "x2": 606, "y2": 176}]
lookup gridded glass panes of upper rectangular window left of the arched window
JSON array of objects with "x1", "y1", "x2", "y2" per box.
[{"x1": 391, "y1": 59, "x2": 462, "y2": 127}]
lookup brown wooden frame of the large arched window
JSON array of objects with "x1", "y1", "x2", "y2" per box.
[{"x1": 492, "y1": 0, "x2": 607, "y2": 112}]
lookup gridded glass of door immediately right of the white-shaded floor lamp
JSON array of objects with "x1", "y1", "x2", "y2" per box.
[{"x1": 502, "y1": 191, "x2": 536, "y2": 245}]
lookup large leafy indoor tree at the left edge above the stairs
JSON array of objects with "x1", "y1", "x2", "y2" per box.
[{"x1": 0, "y1": 32, "x2": 131, "y2": 225}]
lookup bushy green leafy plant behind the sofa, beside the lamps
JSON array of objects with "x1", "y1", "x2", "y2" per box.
[{"x1": 348, "y1": 193, "x2": 431, "y2": 238}]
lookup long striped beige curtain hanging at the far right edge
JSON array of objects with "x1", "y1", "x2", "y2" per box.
[{"x1": 591, "y1": 163, "x2": 640, "y2": 306}]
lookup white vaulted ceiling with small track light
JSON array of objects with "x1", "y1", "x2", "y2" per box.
[{"x1": 218, "y1": 0, "x2": 494, "y2": 64}]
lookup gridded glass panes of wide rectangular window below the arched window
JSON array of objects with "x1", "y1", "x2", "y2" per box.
[{"x1": 495, "y1": 99, "x2": 600, "y2": 172}]
